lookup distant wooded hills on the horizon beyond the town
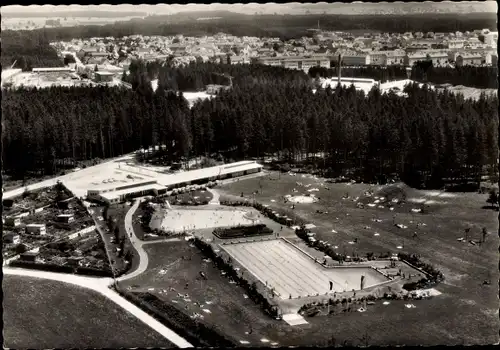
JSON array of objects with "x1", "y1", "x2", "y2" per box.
[{"x1": 2, "y1": 12, "x2": 496, "y2": 44}]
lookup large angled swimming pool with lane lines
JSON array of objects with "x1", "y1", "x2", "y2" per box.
[{"x1": 222, "y1": 240, "x2": 388, "y2": 299}]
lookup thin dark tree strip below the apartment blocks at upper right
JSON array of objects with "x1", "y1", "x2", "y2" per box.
[{"x1": 309, "y1": 62, "x2": 498, "y2": 89}]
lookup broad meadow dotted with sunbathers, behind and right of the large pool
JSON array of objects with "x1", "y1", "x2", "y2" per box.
[{"x1": 217, "y1": 173, "x2": 499, "y2": 345}]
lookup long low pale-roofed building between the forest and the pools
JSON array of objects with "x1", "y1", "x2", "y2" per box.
[{"x1": 87, "y1": 161, "x2": 263, "y2": 204}]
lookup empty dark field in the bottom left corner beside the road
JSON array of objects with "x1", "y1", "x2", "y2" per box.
[{"x1": 3, "y1": 275, "x2": 174, "y2": 349}]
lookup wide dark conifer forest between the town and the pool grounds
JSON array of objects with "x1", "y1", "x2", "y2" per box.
[{"x1": 2, "y1": 64, "x2": 498, "y2": 187}]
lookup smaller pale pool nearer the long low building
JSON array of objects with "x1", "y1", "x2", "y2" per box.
[{"x1": 150, "y1": 209, "x2": 260, "y2": 232}]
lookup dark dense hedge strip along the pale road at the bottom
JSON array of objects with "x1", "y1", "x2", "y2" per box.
[{"x1": 116, "y1": 288, "x2": 235, "y2": 347}]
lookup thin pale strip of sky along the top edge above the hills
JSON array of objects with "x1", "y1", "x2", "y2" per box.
[{"x1": 1, "y1": 1, "x2": 498, "y2": 14}]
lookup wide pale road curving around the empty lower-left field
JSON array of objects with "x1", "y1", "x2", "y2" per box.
[{"x1": 3, "y1": 267, "x2": 193, "y2": 348}]
